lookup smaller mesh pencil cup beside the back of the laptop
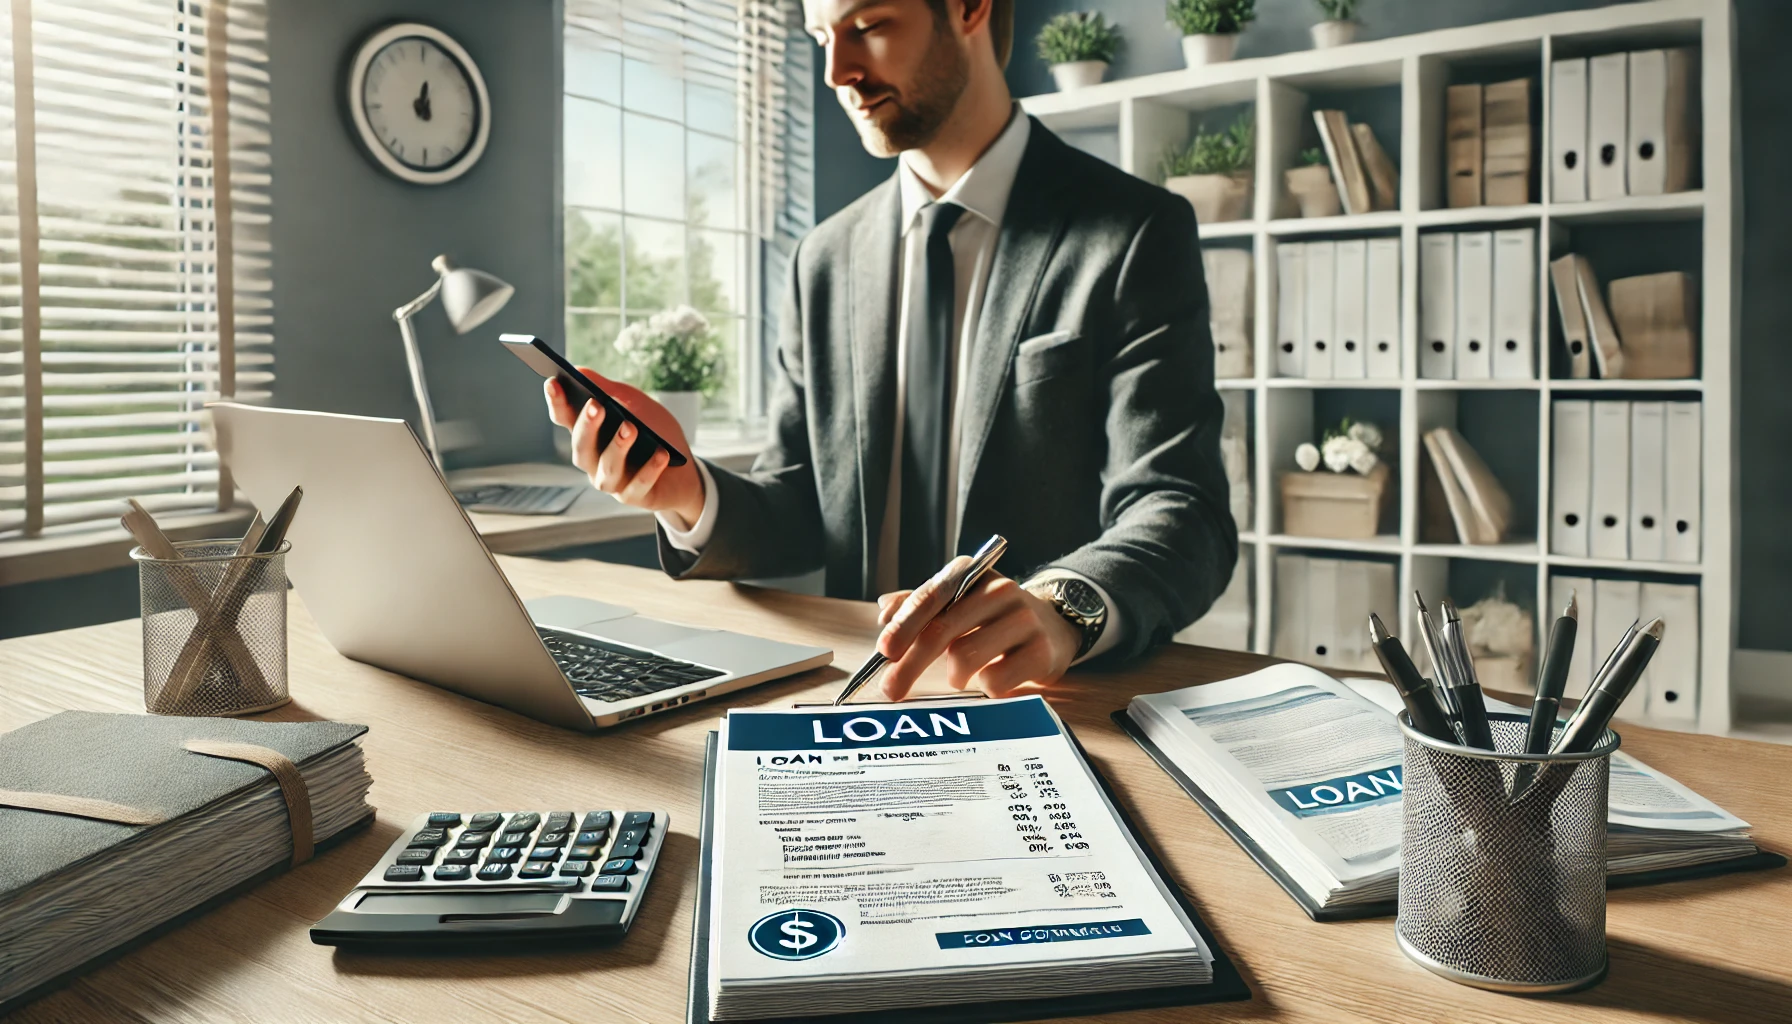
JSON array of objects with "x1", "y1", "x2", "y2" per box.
[{"x1": 131, "y1": 540, "x2": 292, "y2": 716}]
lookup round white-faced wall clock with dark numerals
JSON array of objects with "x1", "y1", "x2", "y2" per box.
[{"x1": 348, "y1": 22, "x2": 491, "y2": 185}]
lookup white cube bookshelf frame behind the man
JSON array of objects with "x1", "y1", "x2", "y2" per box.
[{"x1": 1021, "y1": 0, "x2": 1742, "y2": 733}]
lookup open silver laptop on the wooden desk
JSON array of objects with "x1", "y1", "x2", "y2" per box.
[{"x1": 210, "y1": 402, "x2": 833, "y2": 732}]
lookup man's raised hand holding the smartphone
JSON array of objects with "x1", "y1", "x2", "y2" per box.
[{"x1": 543, "y1": 366, "x2": 702, "y2": 529}]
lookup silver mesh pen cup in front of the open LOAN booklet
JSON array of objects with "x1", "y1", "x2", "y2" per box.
[{"x1": 1394, "y1": 714, "x2": 1618, "y2": 994}]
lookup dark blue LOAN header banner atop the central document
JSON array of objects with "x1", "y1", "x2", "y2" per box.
[{"x1": 728, "y1": 698, "x2": 1059, "y2": 750}]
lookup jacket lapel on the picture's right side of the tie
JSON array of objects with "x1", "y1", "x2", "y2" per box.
[{"x1": 957, "y1": 120, "x2": 1070, "y2": 534}]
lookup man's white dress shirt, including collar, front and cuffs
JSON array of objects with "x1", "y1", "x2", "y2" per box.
[{"x1": 658, "y1": 106, "x2": 1120, "y2": 658}]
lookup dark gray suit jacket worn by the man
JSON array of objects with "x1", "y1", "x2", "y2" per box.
[{"x1": 659, "y1": 120, "x2": 1238, "y2": 658}]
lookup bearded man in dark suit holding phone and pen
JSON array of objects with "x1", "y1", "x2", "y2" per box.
[{"x1": 548, "y1": 0, "x2": 1238, "y2": 699}]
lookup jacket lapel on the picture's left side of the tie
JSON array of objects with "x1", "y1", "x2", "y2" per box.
[{"x1": 848, "y1": 176, "x2": 901, "y2": 592}]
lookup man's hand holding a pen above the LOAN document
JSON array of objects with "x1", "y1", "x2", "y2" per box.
[{"x1": 878, "y1": 554, "x2": 1082, "y2": 701}]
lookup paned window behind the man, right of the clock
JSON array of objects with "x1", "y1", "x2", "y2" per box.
[{"x1": 561, "y1": 0, "x2": 814, "y2": 429}]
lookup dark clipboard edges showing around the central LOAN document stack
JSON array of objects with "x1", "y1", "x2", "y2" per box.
[{"x1": 685, "y1": 726, "x2": 1251, "y2": 1024}]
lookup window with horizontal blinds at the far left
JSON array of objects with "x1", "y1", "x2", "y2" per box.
[{"x1": 0, "y1": 0, "x2": 274, "y2": 538}]
